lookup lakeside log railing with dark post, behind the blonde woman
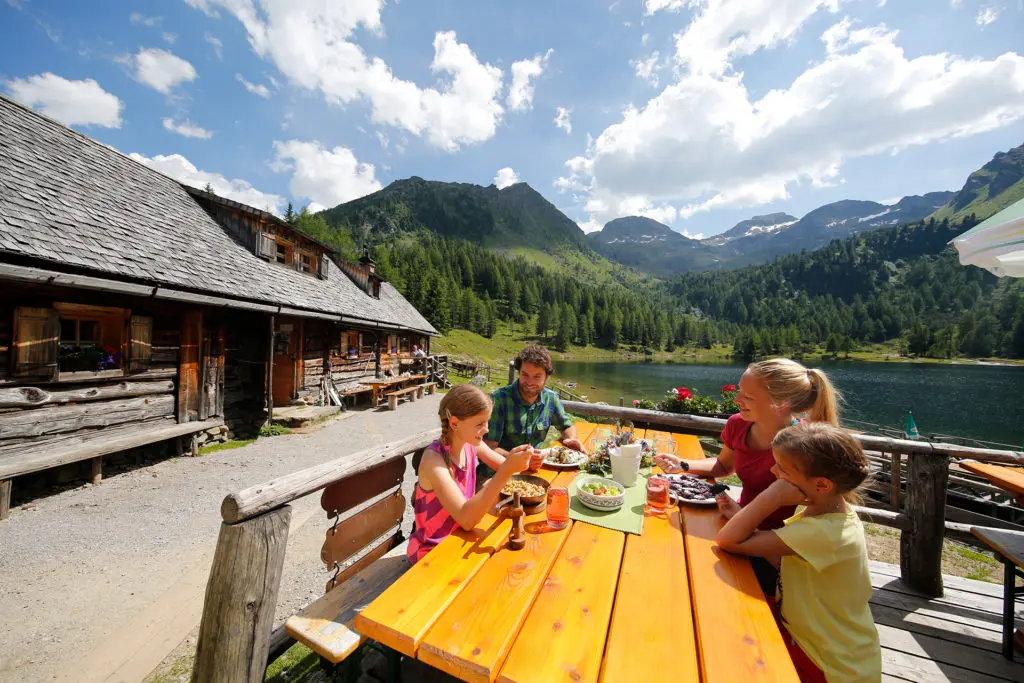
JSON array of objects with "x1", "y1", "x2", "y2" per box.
[{"x1": 565, "y1": 401, "x2": 1024, "y2": 596}]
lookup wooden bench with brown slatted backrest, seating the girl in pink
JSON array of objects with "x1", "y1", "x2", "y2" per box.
[{"x1": 285, "y1": 458, "x2": 410, "y2": 671}]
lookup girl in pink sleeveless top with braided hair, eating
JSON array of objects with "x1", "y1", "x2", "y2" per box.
[{"x1": 407, "y1": 384, "x2": 540, "y2": 564}]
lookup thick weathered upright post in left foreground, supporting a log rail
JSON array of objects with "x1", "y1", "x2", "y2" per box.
[{"x1": 191, "y1": 505, "x2": 292, "y2": 683}]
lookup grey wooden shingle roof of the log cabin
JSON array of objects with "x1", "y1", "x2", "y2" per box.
[{"x1": 0, "y1": 95, "x2": 436, "y2": 334}]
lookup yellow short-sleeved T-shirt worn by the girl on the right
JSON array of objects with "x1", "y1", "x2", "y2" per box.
[{"x1": 775, "y1": 512, "x2": 882, "y2": 683}]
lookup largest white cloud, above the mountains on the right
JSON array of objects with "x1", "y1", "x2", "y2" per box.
[{"x1": 556, "y1": 2, "x2": 1024, "y2": 227}]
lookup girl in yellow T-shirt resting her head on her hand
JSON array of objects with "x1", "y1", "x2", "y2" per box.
[{"x1": 718, "y1": 422, "x2": 882, "y2": 683}]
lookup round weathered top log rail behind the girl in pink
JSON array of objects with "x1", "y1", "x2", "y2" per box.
[{"x1": 220, "y1": 428, "x2": 441, "y2": 524}]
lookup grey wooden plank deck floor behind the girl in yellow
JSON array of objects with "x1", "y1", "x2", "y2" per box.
[{"x1": 871, "y1": 562, "x2": 1024, "y2": 683}]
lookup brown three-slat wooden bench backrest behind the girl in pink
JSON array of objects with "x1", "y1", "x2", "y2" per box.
[{"x1": 321, "y1": 457, "x2": 417, "y2": 592}]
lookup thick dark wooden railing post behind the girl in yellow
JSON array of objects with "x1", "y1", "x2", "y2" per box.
[{"x1": 899, "y1": 455, "x2": 949, "y2": 597}]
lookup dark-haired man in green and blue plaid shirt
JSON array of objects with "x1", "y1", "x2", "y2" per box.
[{"x1": 478, "y1": 344, "x2": 586, "y2": 481}]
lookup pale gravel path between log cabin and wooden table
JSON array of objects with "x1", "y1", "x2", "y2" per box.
[{"x1": 0, "y1": 395, "x2": 440, "y2": 682}]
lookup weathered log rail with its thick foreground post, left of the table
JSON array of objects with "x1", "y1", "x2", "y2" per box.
[{"x1": 193, "y1": 429, "x2": 440, "y2": 683}]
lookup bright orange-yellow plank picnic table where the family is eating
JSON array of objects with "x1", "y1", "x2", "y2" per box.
[{"x1": 355, "y1": 422, "x2": 798, "y2": 683}]
